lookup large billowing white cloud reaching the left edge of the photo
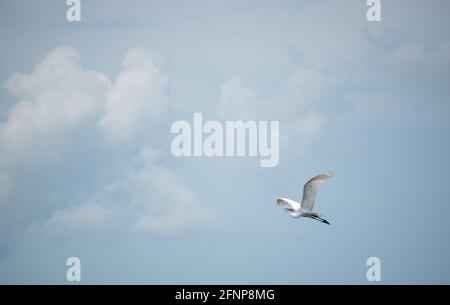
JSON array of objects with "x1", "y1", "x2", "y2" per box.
[{"x1": 0, "y1": 47, "x2": 110, "y2": 152}]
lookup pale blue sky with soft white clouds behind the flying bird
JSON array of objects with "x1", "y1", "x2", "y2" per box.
[{"x1": 0, "y1": 0, "x2": 450, "y2": 284}]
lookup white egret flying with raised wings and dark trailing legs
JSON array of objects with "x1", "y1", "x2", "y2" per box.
[{"x1": 277, "y1": 172, "x2": 333, "y2": 225}]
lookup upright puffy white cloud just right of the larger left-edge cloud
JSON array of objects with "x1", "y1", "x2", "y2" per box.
[{"x1": 99, "y1": 49, "x2": 168, "y2": 140}]
